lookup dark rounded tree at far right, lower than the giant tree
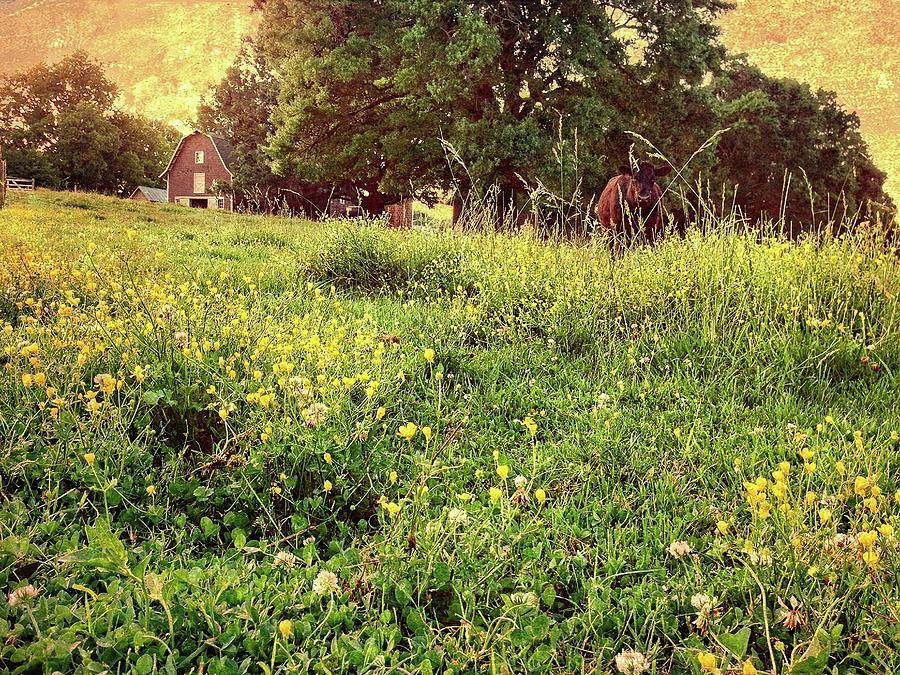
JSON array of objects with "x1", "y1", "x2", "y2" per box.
[{"x1": 713, "y1": 59, "x2": 894, "y2": 231}]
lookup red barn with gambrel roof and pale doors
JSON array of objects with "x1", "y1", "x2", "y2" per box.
[{"x1": 160, "y1": 131, "x2": 234, "y2": 211}]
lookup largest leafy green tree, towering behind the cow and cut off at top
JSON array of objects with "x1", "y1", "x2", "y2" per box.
[{"x1": 258, "y1": 0, "x2": 729, "y2": 218}]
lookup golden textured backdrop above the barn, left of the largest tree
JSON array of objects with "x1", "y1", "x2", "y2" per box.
[{"x1": 0, "y1": 0, "x2": 252, "y2": 128}]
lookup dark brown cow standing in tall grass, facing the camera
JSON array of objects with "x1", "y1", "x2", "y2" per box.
[{"x1": 597, "y1": 161, "x2": 672, "y2": 248}]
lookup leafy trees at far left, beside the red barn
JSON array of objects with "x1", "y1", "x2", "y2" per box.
[{"x1": 0, "y1": 52, "x2": 177, "y2": 194}]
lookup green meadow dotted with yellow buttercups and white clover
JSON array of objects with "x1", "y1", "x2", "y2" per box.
[{"x1": 0, "y1": 192, "x2": 900, "y2": 673}]
